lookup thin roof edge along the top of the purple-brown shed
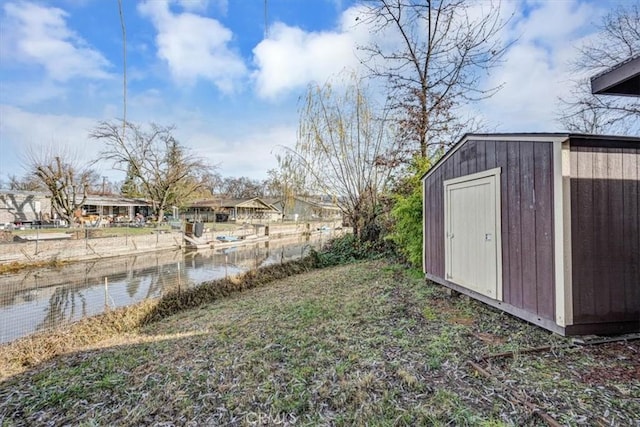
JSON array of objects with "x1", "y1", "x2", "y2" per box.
[{"x1": 420, "y1": 132, "x2": 639, "y2": 180}]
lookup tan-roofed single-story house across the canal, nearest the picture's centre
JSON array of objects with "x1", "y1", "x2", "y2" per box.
[{"x1": 184, "y1": 197, "x2": 281, "y2": 222}]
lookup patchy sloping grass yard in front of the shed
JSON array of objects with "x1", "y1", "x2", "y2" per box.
[{"x1": 0, "y1": 261, "x2": 640, "y2": 426}]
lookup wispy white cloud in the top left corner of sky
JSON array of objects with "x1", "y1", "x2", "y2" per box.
[{"x1": 2, "y1": 2, "x2": 110, "y2": 82}]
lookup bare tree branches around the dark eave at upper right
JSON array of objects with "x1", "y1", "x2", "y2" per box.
[{"x1": 558, "y1": 2, "x2": 640, "y2": 134}]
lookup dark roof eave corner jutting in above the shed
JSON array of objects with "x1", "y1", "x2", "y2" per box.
[{"x1": 591, "y1": 55, "x2": 640, "y2": 96}]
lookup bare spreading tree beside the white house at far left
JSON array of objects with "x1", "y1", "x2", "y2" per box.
[{"x1": 26, "y1": 148, "x2": 97, "y2": 224}]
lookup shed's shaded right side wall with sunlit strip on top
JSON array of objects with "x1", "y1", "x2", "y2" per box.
[{"x1": 570, "y1": 138, "x2": 640, "y2": 328}]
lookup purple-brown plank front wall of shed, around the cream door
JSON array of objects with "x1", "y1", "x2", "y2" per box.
[{"x1": 424, "y1": 140, "x2": 555, "y2": 320}]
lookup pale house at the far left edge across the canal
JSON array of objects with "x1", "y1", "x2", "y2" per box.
[{"x1": 0, "y1": 190, "x2": 53, "y2": 224}]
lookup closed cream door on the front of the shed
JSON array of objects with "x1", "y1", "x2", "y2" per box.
[{"x1": 444, "y1": 169, "x2": 502, "y2": 299}]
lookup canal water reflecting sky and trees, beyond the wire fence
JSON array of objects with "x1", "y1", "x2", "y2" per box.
[{"x1": 0, "y1": 234, "x2": 329, "y2": 344}]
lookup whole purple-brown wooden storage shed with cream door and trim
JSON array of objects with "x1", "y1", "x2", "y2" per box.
[{"x1": 422, "y1": 133, "x2": 640, "y2": 335}]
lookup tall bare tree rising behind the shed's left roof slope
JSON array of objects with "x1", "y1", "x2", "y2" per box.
[{"x1": 358, "y1": 0, "x2": 506, "y2": 157}]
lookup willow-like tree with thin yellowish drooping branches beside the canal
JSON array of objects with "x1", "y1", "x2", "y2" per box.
[{"x1": 290, "y1": 77, "x2": 394, "y2": 237}]
